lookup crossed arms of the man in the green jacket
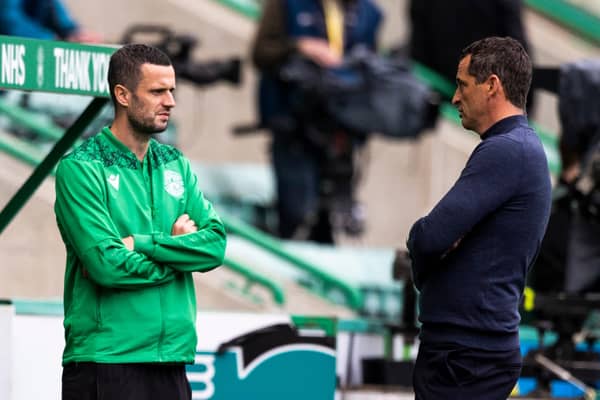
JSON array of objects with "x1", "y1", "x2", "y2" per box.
[{"x1": 55, "y1": 160, "x2": 226, "y2": 289}]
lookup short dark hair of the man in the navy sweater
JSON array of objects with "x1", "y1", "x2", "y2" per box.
[{"x1": 460, "y1": 36, "x2": 532, "y2": 110}]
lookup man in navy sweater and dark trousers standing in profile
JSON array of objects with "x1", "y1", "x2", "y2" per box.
[{"x1": 407, "y1": 37, "x2": 551, "y2": 400}]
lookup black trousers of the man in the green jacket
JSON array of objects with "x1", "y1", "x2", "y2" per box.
[{"x1": 62, "y1": 362, "x2": 192, "y2": 400}]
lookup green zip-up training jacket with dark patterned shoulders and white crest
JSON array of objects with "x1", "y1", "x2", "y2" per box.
[{"x1": 54, "y1": 127, "x2": 226, "y2": 364}]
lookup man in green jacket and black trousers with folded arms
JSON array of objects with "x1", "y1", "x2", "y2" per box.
[{"x1": 55, "y1": 45, "x2": 226, "y2": 400}]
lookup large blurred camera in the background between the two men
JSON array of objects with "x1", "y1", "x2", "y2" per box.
[{"x1": 274, "y1": 51, "x2": 439, "y2": 236}]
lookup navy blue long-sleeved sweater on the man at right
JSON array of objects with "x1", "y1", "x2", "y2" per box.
[{"x1": 407, "y1": 115, "x2": 551, "y2": 350}]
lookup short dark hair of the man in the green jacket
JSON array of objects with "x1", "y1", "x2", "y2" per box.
[{"x1": 108, "y1": 44, "x2": 171, "y2": 105}]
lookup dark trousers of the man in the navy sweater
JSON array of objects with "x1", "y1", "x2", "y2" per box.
[{"x1": 413, "y1": 343, "x2": 522, "y2": 400}]
